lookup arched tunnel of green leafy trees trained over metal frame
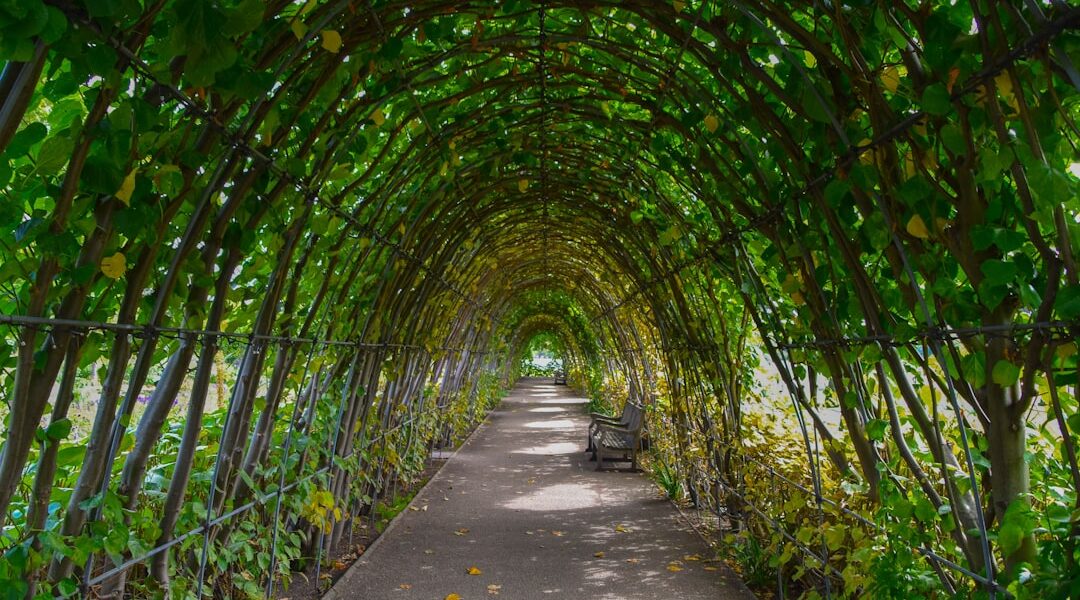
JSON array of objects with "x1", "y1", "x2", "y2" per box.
[{"x1": 0, "y1": 0, "x2": 1080, "y2": 598}]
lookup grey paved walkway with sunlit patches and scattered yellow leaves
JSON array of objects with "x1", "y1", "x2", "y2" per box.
[{"x1": 326, "y1": 379, "x2": 754, "y2": 600}]
